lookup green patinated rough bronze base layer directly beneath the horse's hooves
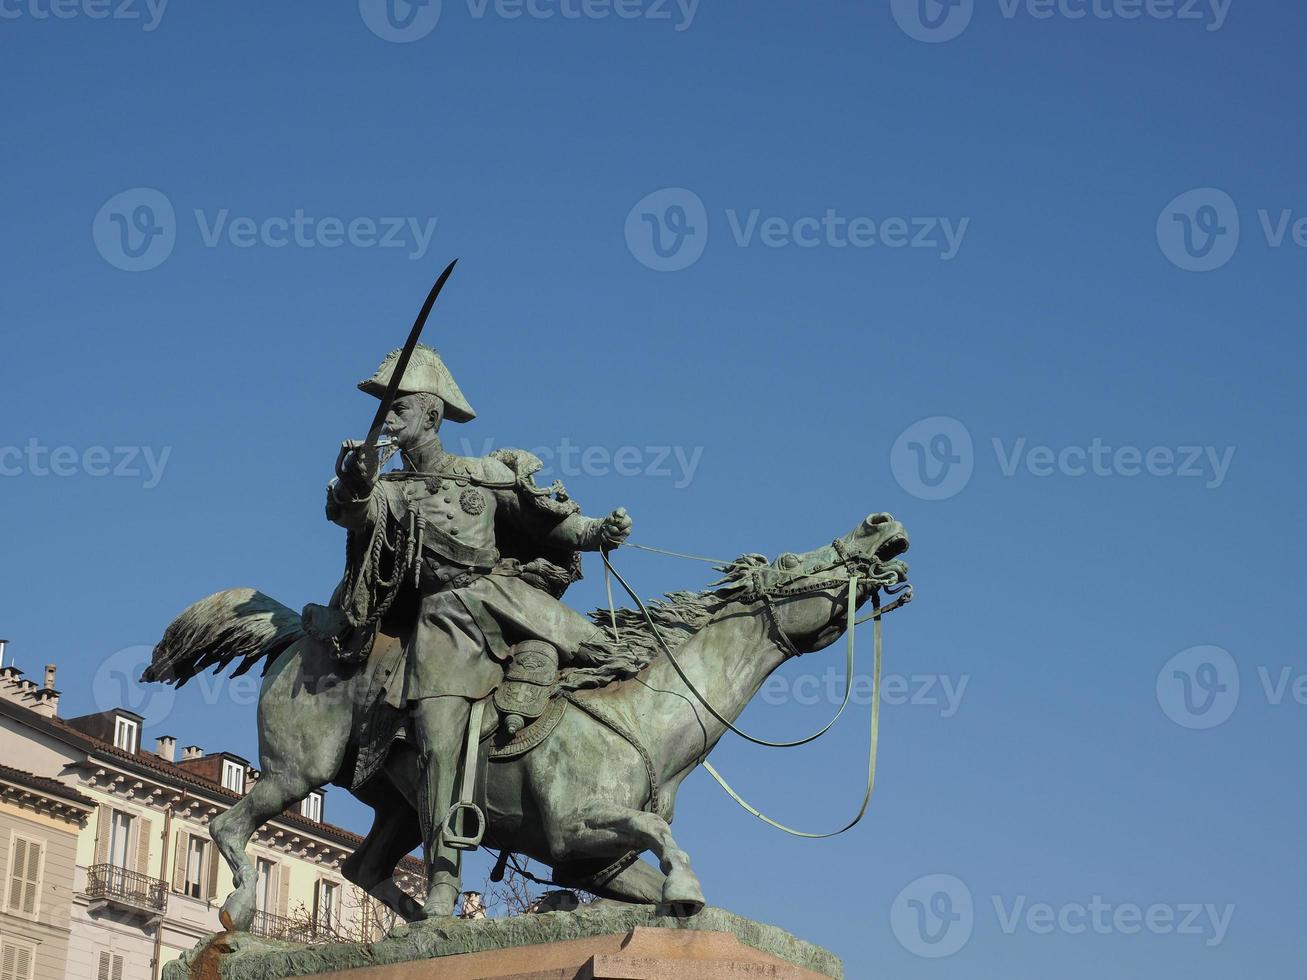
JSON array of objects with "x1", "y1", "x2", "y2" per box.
[{"x1": 163, "y1": 907, "x2": 844, "y2": 980}]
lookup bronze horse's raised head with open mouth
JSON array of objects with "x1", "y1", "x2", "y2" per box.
[{"x1": 746, "y1": 514, "x2": 908, "y2": 653}]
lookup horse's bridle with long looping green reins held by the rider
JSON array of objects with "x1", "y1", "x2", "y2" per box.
[{"x1": 600, "y1": 540, "x2": 912, "y2": 840}]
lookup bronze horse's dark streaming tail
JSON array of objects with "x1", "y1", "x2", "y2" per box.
[{"x1": 141, "y1": 589, "x2": 305, "y2": 687}]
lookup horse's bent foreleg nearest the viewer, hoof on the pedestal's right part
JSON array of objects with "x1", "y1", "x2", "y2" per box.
[{"x1": 550, "y1": 806, "x2": 703, "y2": 915}]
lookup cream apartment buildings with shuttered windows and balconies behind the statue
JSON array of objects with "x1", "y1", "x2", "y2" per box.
[{"x1": 0, "y1": 653, "x2": 423, "y2": 980}]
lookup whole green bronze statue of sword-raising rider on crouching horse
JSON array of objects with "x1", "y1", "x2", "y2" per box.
[{"x1": 144, "y1": 265, "x2": 908, "y2": 930}]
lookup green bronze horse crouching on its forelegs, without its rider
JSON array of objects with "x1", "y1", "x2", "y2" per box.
[{"x1": 144, "y1": 514, "x2": 908, "y2": 929}]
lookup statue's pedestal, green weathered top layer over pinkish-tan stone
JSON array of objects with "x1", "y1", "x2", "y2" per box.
[{"x1": 173, "y1": 907, "x2": 843, "y2": 980}]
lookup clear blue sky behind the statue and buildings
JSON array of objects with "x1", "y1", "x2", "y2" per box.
[{"x1": 0, "y1": 0, "x2": 1307, "y2": 979}]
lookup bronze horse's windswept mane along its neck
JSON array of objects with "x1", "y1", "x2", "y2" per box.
[{"x1": 561, "y1": 554, "x2": 767, "y2": 691}]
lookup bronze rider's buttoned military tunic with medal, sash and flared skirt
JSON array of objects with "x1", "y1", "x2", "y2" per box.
[{"x1": 327, "y1": 451, "x2": 611, "y2": 707}]
